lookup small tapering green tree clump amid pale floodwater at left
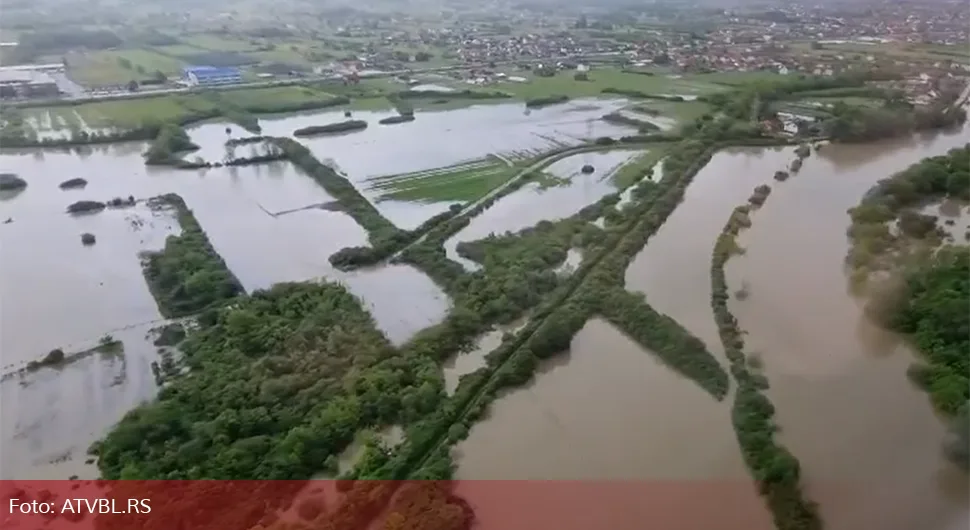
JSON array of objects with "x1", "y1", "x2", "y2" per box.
[{"x1": 142, "y1": 194, "x2": 243, "y2": 318}]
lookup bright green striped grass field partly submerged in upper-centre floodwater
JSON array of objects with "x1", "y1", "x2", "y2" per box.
[{"x1": 368, "y1": 157, "x2": 519, "y2": 202}]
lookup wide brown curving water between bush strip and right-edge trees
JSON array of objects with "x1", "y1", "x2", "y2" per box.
[{"x1": 726, "y1": 129, "x2": 970, "y2": 530}]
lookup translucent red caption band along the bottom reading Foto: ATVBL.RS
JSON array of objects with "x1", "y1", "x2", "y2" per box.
[{"x1": 0, "y1": 480, "x2": 772, "y2": 530}]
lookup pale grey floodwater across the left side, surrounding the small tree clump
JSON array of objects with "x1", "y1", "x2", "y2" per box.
[{"x1": 0, "y1": 136, "x2": 449, "y2": 479}]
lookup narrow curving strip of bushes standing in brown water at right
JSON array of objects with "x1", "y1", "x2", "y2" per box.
[{"x1": 711, "y1": 188, "x2": 822, "y2": 530}]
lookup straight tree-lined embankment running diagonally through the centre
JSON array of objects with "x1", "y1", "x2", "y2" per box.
[{"x1": 384, "y1": 132, "x2": 777, "y2": 478}]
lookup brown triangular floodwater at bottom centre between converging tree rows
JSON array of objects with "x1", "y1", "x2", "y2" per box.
[{"x1": 455, "y1": 319, "x2": 771, "y2": 530}]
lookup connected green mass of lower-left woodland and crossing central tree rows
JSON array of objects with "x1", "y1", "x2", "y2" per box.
[{"x1": 97, "y1": 109, "x2": 808, "y2": 529}]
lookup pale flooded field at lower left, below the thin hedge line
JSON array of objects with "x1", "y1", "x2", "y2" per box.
[{"x1": 0, "y1": 324, "x2": 160, "y2": 480}]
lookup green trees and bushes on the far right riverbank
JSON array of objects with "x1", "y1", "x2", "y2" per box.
[{"x1": 847, "y1": 144, "x2": 970, "y2": 466}]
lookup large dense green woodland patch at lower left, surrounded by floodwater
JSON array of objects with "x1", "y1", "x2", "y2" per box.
[{"x1": 97, "y1": 283, "x2": 441, "y2": 479}]
